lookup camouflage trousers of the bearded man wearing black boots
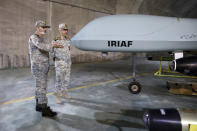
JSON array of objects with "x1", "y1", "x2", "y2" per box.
[{"x1": 32, "y1": 62, "x2": 49, "y2": 104}]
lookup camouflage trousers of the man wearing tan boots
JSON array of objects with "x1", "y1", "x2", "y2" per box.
[{"x1": 55, "y1": 60, "x2": 71, "y2": 93}]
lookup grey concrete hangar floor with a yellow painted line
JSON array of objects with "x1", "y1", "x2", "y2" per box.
[{"x1": 0, "y1": 58, "x2": 197, "y2": 131}]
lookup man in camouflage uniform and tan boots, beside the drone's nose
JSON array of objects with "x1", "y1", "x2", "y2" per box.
[{"x1": 52, "y1": 24, "x2": 71, "y2": 104}]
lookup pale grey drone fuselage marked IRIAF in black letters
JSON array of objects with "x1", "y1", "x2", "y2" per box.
[{"x1": 72, "y1": 15, "x2": 197, "y2": 52}]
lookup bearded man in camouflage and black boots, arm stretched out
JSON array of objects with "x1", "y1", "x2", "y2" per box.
[{"x1": 29, "y1": 20, "x2": 63, "y2": 117}]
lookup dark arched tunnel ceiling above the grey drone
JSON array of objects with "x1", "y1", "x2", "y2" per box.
[{"x1": 47, "y1": 0, "x2": 197, "y2": 18}]
